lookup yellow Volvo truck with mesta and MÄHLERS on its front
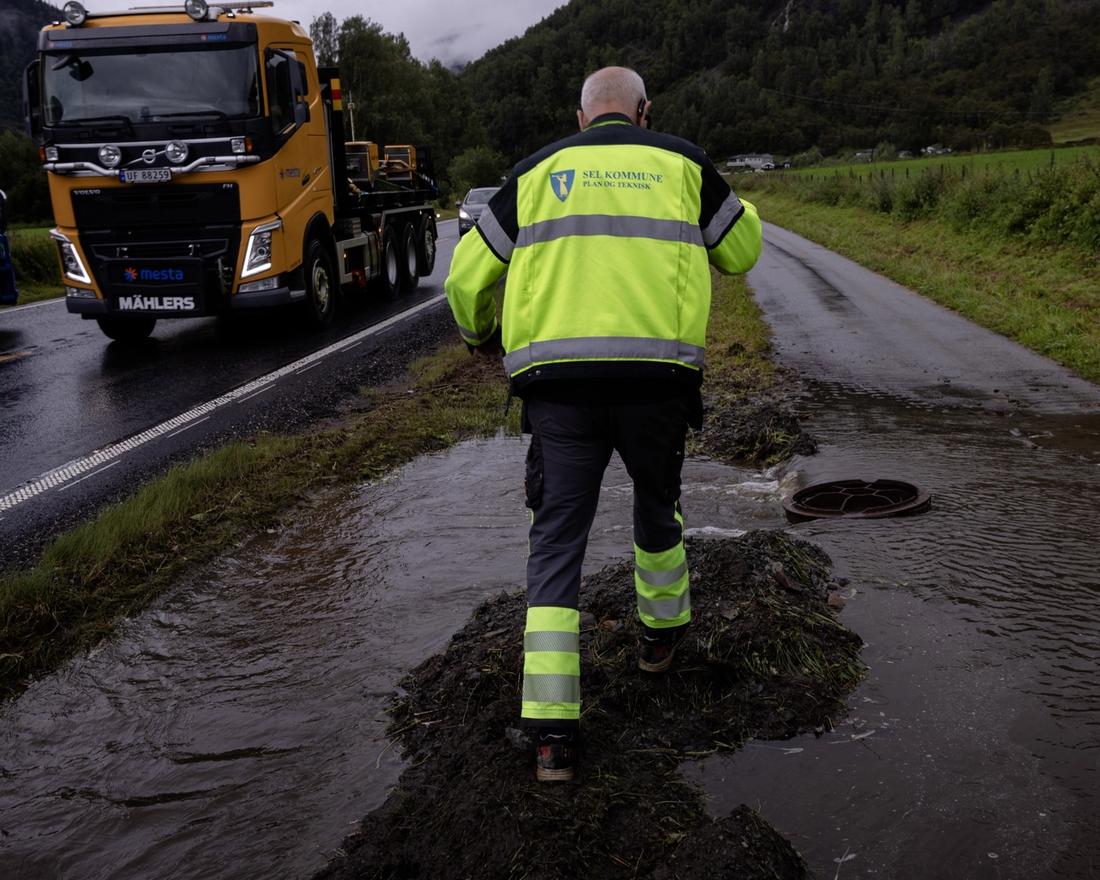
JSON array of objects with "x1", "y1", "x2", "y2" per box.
[{"x1": 23, "y1": 0, "x2": 438, "y2": 340}]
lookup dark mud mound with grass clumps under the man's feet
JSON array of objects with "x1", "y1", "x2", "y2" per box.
[{"x1": 318, "y1": 531, "x2": 864, "y2": 880}]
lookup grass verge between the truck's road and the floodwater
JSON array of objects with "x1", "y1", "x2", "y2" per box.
[{"x1": 0, "y1": 278, "x2": 768, "y2": 697}]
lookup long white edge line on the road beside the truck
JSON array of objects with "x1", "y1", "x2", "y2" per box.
[{"x1": 0, "y1": 294, "x2": 446, "y2": 513}]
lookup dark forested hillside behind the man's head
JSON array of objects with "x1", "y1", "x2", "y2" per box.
[{"x1": 461, "y1": 0, "x2": 1100, "y2": 157}]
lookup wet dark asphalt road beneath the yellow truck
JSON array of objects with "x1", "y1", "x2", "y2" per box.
[{"x1": 0, "y1": 221, "x2": 458, "y2": 568}]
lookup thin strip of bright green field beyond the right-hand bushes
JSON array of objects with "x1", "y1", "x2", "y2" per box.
[{"x1": 769, "y1": 146, "x2": 1100, "y2": 177}]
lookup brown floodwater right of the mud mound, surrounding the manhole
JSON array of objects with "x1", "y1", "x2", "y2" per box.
[{"x1": 690, "y1": 388, "x2": 1100, "y2": 880}]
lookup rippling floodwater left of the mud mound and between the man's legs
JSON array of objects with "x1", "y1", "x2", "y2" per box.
[{"x1": 0, "y1": 438, "x2": 778, "y2": 880}]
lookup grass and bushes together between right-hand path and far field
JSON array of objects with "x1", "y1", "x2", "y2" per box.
[{"x1": 733, "y1": 158, "x2": 1100, "y2": 382}]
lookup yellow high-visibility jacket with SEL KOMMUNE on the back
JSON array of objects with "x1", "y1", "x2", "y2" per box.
[{"x1": 444, "y1": 113, "x2": 761, "y2": 394}]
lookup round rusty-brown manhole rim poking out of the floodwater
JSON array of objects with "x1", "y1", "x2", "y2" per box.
[{"x1": 783, "y1": 480, "x2": 932, "y2": 523}]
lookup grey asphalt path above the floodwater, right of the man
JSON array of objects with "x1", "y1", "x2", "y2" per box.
[{"x1": 748, "y1": 223, "x2": 1100, "y2": 414}]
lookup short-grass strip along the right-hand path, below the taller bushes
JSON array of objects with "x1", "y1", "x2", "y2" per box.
[{"x1": 748, "y1": 193, "x2": 1100, "y2": 383}]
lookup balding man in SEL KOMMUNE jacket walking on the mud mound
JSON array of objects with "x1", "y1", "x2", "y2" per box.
[{"x1": 444, "y1": 67, "x2": 761, "y2": 781}]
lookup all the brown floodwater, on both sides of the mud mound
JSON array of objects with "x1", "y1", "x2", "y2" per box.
[{"x1": 0, "y1": 396, "x2": 1100, "y2": 880}]
